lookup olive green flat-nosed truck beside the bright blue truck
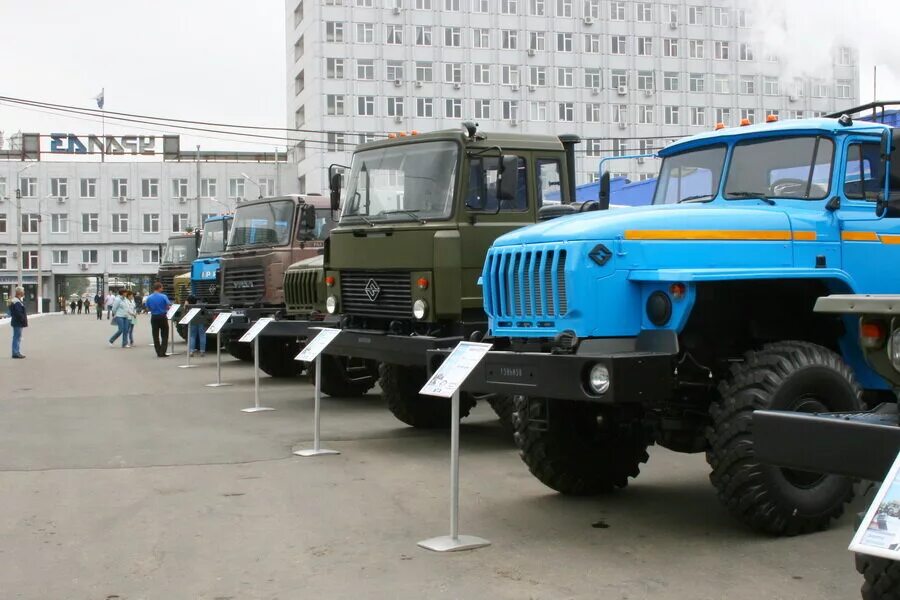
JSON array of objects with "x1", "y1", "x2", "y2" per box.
[{"x1": 325, "y1": 122, "x2": 584, "y2": 427}]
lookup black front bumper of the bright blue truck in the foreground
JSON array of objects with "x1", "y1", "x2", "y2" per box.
[{"x1": 428, "y1": 351, "x2": 674, "y2": 405}]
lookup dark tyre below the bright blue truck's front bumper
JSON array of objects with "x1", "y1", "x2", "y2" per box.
[{"x1": 513, "y1": 396, "x2": 650, "y2": 496}]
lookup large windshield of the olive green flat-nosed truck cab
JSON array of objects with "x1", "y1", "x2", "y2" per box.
[{"x1": 341, "y1": 142, "x2": 459, "y2": 223}]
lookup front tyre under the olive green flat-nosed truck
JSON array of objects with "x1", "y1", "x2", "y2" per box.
[{"x1": 378, "y1": 364, "x2": 475, "y2": 429}]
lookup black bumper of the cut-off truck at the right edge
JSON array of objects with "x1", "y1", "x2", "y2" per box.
[{"x1": 753, "y1": 404, "x2": 900, "y2": 481}]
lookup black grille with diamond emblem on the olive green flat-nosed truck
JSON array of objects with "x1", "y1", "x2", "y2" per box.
[{"x1": 341, "y1": 271, "x2": 412, "y2": 319}]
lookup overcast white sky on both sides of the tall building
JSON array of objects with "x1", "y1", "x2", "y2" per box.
[{"x1": 0, "y1": 0, "x2": 900, "y2": 155}]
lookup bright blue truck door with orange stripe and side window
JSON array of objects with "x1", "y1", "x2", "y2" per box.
[{"x1": 838, "y1": 138, "x2": 900, "y2": 294}]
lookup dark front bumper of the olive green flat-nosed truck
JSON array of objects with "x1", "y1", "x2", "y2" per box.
[{"x1": 325, "y1": 329, "x2": 462, "y2": 367}]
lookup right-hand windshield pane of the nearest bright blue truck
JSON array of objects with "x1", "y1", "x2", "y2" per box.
[{"x1": 725, "y1": 136, "x2": 834, "y2": 200}]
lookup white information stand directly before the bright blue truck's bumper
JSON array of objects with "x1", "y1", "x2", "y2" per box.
[{"x1": 419, "y1": 342, "x2": 491, "y2": 552}]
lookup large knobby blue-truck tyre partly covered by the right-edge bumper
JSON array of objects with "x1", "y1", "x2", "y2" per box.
[{"x1": 706, "y1": 342, "x2": 862, "y2": 535}]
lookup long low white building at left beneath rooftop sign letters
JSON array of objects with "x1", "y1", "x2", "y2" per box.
[{"x1": 0, "y1": 134, "x2": 296, "y2": 306}]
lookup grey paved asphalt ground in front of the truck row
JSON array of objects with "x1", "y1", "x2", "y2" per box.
[{"x1": 0, "y1": 315, "x2": 862, "y2": 600}]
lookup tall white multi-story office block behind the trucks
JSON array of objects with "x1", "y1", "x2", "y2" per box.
[{"x1": 285, "y1": 0, "x2": 859, "y2": 192}]
